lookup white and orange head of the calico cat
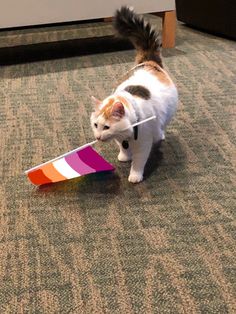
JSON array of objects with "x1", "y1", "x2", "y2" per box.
[{"x1": 90, "y1": 96, "x2": 133, "y2": 141}]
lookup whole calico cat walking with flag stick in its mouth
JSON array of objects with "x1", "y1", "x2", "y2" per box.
[{"x1": 90, "y1": 7, "x2": 178, "y2": 183}]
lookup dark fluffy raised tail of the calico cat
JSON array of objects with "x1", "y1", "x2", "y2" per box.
[{"x1": 114, "y1": 6, "x2": 162, "y2": 66}]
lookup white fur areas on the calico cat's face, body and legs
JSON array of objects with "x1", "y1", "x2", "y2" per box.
[{"x1": 91, "y1": 69, "x2": 178, "y2": 183}]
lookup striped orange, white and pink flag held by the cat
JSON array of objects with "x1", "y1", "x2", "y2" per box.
[{"x1": 26, "y1": 146, "x2": 115, "y2": 185}]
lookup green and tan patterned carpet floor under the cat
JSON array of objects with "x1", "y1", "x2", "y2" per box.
[{"x1": 0, "y1": 18, "x2": 236, "y2": 314}]
